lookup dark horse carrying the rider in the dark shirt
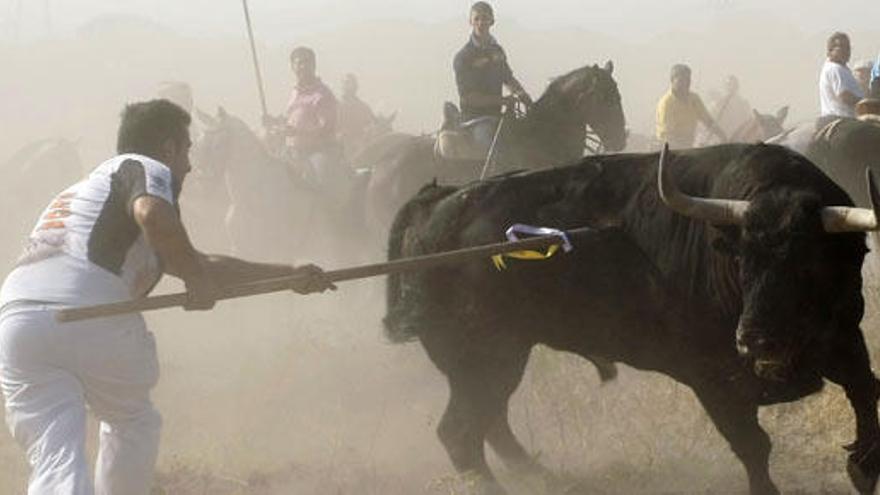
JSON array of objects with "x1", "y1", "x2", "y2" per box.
[{"x1": 365, "y1": 61, "x2": 627, "y2": 243}]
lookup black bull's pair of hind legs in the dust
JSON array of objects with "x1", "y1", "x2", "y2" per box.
[{"x1": 435, "y1": 340, "x2": 534, "y2": 495}]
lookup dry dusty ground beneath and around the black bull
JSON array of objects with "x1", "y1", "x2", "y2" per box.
[{"x1": 0, "y1": 283, "x2": 876, "y2": 495}]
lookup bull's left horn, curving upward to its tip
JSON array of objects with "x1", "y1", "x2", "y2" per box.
[{"x1": 657, "y1": 143, "x2": 749, "y2": 225}]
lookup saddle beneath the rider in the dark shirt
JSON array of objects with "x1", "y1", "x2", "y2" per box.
[{"x1": 434, "y1": 101, "x2": 496, "y2": 163}]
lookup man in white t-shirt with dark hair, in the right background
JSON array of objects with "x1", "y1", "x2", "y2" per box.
[{"x1": 819, "y1": 32, "x2": 865, "y2": 117}]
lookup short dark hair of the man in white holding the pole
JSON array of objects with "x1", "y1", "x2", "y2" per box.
[{"x1": 116, "y1": 100, "x2": 190, "y2": 158}]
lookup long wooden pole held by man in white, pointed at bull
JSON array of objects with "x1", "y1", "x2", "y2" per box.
[{"x1": 56, "y1": 227, "x2": 593, "y2": 322}]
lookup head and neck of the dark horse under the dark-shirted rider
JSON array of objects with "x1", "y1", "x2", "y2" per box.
[{"x1": 536, "y1": 61, "x2": 626, "y2": 151}]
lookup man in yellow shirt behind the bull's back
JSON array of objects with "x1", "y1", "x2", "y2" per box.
[{"x1": 657, "y1": 64, "x2": 727, "y2": 149}]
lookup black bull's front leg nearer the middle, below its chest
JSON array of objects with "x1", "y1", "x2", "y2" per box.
[{"x1": 694, "y1": 386, "x2": 779, "y2": 495}]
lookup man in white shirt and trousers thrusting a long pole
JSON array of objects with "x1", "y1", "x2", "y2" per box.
[{"x1": 0, "y1": 100, "x2": 332, "y2": 495}]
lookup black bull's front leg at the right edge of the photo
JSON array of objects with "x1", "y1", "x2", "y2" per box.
[{"x1": 824, "y1": 328, "x2": 880, "y2": 493}]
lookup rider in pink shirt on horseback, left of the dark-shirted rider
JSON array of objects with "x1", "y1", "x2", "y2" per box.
[{"x1": 263, "y1": 46, "x2": 351, "y2": 199}]
